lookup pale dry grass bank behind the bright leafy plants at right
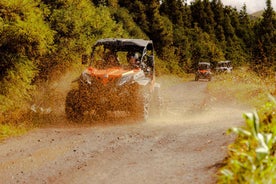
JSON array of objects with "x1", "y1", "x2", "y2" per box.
[{"x1": 208, "y1": 67, "x2": 276, "y2": 107}]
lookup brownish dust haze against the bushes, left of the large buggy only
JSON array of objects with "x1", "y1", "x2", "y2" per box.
[{"x1": 30, "y1": 68, "x2": 81, "y2": 126}]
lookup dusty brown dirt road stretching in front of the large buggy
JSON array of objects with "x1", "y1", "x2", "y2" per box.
[{"x1": 0, "y1": 81, "x2": 248, "y2": 184}]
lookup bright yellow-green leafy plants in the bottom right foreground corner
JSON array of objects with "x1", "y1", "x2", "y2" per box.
[{"x1": 218, "y1": 97, "x2": 276, "y2": 184}]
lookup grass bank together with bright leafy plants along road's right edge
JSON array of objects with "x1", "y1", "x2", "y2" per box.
[{"x1": 208, "y1": 67, "x2": 276, "y2": 184}]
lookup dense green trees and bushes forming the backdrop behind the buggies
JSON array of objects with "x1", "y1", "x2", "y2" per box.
[{"x1": 0, "y1": 0, "x2": 276, "y2": 122}]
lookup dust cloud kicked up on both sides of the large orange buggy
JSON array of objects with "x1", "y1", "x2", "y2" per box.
[{"x1": 31, "y1": 69, "x2": 247, "y2": 127}]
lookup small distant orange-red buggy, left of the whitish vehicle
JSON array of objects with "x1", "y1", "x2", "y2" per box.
[{"x1": 195, "y1": 62, "x2": 212, "y2": 81}]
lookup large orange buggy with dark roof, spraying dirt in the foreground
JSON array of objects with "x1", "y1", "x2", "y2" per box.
[{"x1": 65, "y1": 38, "x2": 159, "y2": 121}]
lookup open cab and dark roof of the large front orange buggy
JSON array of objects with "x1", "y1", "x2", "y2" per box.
[{"x1": 90, "y1": 38, "x2": 154, "y2": 70}]
